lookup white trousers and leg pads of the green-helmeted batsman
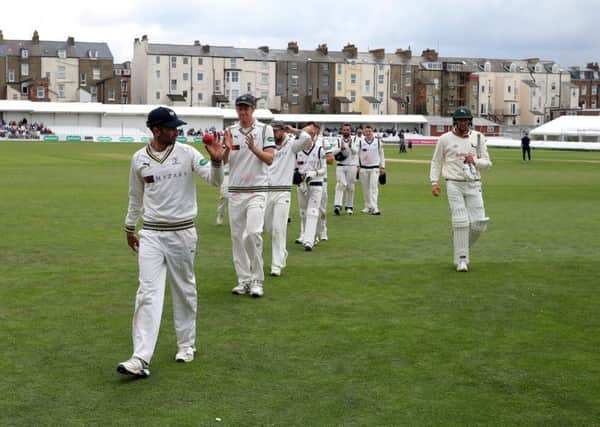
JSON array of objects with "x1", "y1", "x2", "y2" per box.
[{"x1": 446, "y1": 180, "x2": 489, "y2": 265}]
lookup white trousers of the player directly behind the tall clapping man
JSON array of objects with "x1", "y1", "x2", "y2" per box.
[{"x1": 265, "y1": 191, "x2": 291, "y2": 270}]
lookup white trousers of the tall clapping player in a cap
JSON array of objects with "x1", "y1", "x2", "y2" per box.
[{"x1": 229, "y1": 192, "x2": 267, "y2": 284}]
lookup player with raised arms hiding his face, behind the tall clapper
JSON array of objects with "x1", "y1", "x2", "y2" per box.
[{"x1": 265, "y1": 121, "x2": 317, "y2": 276}]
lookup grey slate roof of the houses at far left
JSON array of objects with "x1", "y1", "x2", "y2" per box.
[{"x1": 0, "y1": 40, "x2": 113, "y2": 60}]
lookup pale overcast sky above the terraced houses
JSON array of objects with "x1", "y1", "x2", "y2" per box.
[{"x1": 0, "y1": 0, "x2": 600, "y2": 67}]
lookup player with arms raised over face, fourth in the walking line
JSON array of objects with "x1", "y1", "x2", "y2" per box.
[{"x1": 296, "y1": 122, "x2": 327, "y2": 251}]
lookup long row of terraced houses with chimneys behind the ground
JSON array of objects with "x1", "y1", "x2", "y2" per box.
[{"x1": 0, "y1": 31, "x2": 600, "y2": 126}]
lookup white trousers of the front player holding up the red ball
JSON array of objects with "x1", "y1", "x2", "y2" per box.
[{"x1": 132, "y1": 227, "x2": 198, "y2": 363}]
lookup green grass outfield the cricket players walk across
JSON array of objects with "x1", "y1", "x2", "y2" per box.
[{"x1": 0, "y1": 142, "x2": 600, "y2": 426}]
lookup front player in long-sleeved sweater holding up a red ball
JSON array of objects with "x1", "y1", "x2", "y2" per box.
[{"x1": 117, "y1": 107, "x2": 223, "y2": 377}]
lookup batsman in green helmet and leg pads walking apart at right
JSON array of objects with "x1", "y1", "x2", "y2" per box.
[{"x1": 429, "y1": 107, "x2": 492, "y2": 272}]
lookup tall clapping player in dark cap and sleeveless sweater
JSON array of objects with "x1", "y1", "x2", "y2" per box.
[{"x1": 223, "y1": 94, "x2": 275, "y2": 298}]
